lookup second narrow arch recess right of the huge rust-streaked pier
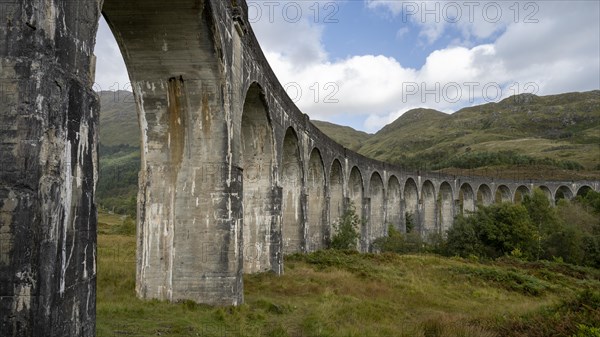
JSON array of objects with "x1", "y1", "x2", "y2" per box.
[{"x1": 279, "y1": 127, "x2": 304, "y2": 254}]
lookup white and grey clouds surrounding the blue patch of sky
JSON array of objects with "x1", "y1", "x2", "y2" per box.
[{"x1": 91, "y1": 0, "x2": 600, "y2": 132}]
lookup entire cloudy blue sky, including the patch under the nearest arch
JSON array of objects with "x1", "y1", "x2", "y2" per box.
[{"x1": 95, "y1": 0, "x2": 600, "y2": 133}]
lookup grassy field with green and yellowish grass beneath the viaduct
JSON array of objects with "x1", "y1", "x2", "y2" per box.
[{"x1": 97, "y1": 214, "x2": 600, "y2": 337}]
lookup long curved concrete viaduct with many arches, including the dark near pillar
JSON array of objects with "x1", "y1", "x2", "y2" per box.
[{"x1": 0, "y1": 0, "x2": 600, "y2": 337}]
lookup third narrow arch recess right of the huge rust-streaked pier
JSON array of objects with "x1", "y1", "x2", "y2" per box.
[{"x1": 306, "y1": 148, "x2": 326, "y2": 252}]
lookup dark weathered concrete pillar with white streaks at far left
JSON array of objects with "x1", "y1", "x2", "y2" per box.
[{"x1": 0, "y1": 0, "x2": 100, "y2": 337}]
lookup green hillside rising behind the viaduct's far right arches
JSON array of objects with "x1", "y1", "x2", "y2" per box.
[{"x1": 316, "y1": 90, "x2": 600, "y2": 170}]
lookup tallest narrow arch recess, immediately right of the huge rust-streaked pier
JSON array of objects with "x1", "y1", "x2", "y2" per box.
[{"x1": 240, "y1": 84, "x2": 274, "y2": 273}]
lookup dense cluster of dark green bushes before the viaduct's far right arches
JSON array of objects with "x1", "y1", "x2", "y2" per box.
[{"x1": 445, "y1": 189, "x2": 600, "y2": 267}]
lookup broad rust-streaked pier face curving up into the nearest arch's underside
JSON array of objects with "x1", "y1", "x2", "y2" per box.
[{"x1": 101, "y1": 0, "x2": 241, "y2": 305}]
